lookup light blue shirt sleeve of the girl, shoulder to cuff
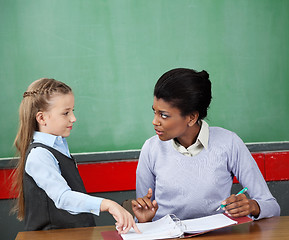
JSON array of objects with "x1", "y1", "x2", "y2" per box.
[{"x1": 25, "y1": 147, "x2": 103, "y2": 215}]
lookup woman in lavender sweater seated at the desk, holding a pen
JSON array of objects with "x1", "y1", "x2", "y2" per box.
[{"x1": 132, "y1": 68, "x2": 280, "y2": 222}]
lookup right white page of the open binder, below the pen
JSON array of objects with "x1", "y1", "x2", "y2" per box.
[{"x1": 182, "y1": 213, "x2": 238, "y2": 233}]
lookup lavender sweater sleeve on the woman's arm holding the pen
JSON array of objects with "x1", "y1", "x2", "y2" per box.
[{"x1": 230, "y1": 134, "x2": 280, "y2": 220}]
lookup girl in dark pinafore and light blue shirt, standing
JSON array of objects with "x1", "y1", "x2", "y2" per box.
[{"x1": 14, "y1": 78, "x2": 138, "y2": 233}]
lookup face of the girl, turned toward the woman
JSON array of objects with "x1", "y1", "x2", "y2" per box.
[{"x1": 40, "y1": 93, "x2": 76, "y2": 137}]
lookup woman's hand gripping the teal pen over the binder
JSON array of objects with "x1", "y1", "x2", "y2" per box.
[{"x1": 222, "y1": 194, "x2": 260, "y2": 217}]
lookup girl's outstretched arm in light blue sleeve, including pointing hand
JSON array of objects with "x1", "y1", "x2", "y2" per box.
[{"x1": 25, "y1": 147, "x2": 139, "y2": 233}]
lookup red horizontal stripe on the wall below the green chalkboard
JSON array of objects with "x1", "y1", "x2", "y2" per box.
[{"x1": 0, "y1": 152, "x2": 289, "y2": 199}]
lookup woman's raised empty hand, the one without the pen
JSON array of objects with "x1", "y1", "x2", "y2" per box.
[{"x1": 131, "y1": 188, "x2": 159, "y2": 223}]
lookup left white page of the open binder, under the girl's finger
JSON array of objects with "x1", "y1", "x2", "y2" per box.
[{"x1": 121, "y1": 215, "x2": 182, "y2": 240}]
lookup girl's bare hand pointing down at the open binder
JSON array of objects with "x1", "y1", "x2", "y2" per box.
[{"x1": 100, "y1": 199, "x2": 140, "y2": 234}]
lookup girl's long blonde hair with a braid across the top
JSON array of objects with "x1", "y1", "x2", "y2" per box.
[{"x1": 13, "y1": 78, "x2": 72, "y2": 221}]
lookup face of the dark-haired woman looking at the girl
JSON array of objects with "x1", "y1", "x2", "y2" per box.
[{"x1": 152, "y1": 97, "x2": 191, "y2": 141}]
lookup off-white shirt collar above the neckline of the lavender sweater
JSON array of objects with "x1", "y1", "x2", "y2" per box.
[{"x1": 172, "y1": 120, "x2": 209, "y2": 157}]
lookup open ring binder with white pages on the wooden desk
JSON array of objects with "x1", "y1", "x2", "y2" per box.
[{"x1": 121, "y1": 213, "x2": 252, "y2": 240}]
